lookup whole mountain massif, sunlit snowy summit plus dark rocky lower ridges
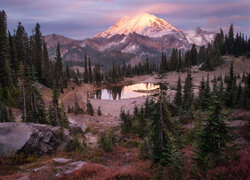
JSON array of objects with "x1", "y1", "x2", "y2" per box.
[{"x1": 45, "y1": 13, "x2": 215, "y2": 65}]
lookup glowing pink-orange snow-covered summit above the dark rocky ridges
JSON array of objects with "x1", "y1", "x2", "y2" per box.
[{"x1": 95, "y1": 13, "x2": 183, "y2": 38}]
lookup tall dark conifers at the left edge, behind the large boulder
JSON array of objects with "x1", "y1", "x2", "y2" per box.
[{"x1": 0, "y1": 10, "x2": 69, "y2": 127}]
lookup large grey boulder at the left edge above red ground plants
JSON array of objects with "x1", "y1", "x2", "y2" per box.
[{"x1": 0, "y1": 122, "x2": 72, "y2": 156}]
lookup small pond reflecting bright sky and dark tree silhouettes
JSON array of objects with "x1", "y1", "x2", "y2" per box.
[{"x1": 90, "y1": 83, "x2": 159, "y2": 100}]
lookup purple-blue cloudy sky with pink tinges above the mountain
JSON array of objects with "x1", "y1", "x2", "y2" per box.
[{"x1": 0, "y1": 0, "x2": 250, "y2": 40}]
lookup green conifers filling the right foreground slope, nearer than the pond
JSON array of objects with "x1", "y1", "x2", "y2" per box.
[{"x1": 120, "y1": 64, "x2": 250, "y2": 179}]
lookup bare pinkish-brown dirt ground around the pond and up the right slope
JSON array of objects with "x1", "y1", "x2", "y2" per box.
[{"x1": 37, "y1": 57, "x2": 250, "y2": 133}]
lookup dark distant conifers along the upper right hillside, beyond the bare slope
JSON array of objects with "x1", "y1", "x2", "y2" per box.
[{"x1": 160, "y1": 24, "x2": 250, "y2": 73}]
